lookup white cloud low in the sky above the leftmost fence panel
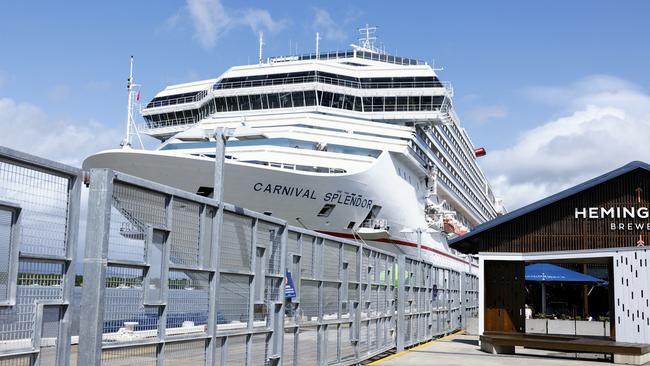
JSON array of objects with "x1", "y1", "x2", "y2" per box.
[{"x1": 0, "y1": 98, "x2": 121, "y2": 166}]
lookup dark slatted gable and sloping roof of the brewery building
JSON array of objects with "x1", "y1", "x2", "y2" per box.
[{"x1": 448, "y1": 161, "x2": 650, "y2": 254}]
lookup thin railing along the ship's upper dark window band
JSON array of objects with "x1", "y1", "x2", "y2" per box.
[{"x1": 213, "y1": 75, "x2": 453, "y2": 92}]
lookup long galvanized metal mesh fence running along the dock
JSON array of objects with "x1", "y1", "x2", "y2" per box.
[{"x1": 0, "y1": 150, "x2": 478, "y2": 366}]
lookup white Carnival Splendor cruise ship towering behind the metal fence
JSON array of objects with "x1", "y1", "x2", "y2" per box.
[{"x1": 83, "y1": 26, "x2": 504, "y2": 270}]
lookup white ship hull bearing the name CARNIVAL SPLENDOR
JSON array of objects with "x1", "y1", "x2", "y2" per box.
[{"x1": 84, "y1": 150, "x2": 470, "y2": 271}]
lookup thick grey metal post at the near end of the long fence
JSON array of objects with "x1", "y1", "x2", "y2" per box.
[{"x1": 77, "y1": 169, "x2": 113, "y2": 366}]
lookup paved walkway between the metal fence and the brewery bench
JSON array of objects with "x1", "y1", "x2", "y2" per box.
[{"x1": 371, "y1": 335, "x2": 605, "y2": 366}]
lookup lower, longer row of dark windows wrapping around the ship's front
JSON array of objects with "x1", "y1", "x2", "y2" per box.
[{"x1": 144, "y1": 90, "x2": 444, "y2": 128}]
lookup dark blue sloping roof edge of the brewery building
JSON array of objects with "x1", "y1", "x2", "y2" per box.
[{"x1": 449, "y1": 161, "x2": 650, "y2": 250}]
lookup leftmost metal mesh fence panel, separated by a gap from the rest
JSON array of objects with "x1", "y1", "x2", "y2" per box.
[{"x1": 0, "y1": 147, "x2": 80, "y2": 366}]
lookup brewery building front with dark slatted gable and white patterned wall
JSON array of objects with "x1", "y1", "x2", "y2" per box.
[{"x1": 450, "y1": 162, "x2": 650, "y2": 360}]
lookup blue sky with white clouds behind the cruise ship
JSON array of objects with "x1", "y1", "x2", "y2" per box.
[{"x1": 0, "y1": 0, "x2": 650, "y2": 210}]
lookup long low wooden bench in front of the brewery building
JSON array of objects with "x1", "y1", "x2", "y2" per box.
[{"x1": 480, "y1": 332, "x2": 650, "y2": 365}]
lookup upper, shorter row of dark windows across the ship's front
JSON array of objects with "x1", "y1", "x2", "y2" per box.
[{"x1": 212, "y1": 71, "x2": 443, "y2": 90}]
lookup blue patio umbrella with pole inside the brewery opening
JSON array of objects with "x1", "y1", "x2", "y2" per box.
[{"x1": 526, "y1": 263, "x2": 607, "y2": 313}]
